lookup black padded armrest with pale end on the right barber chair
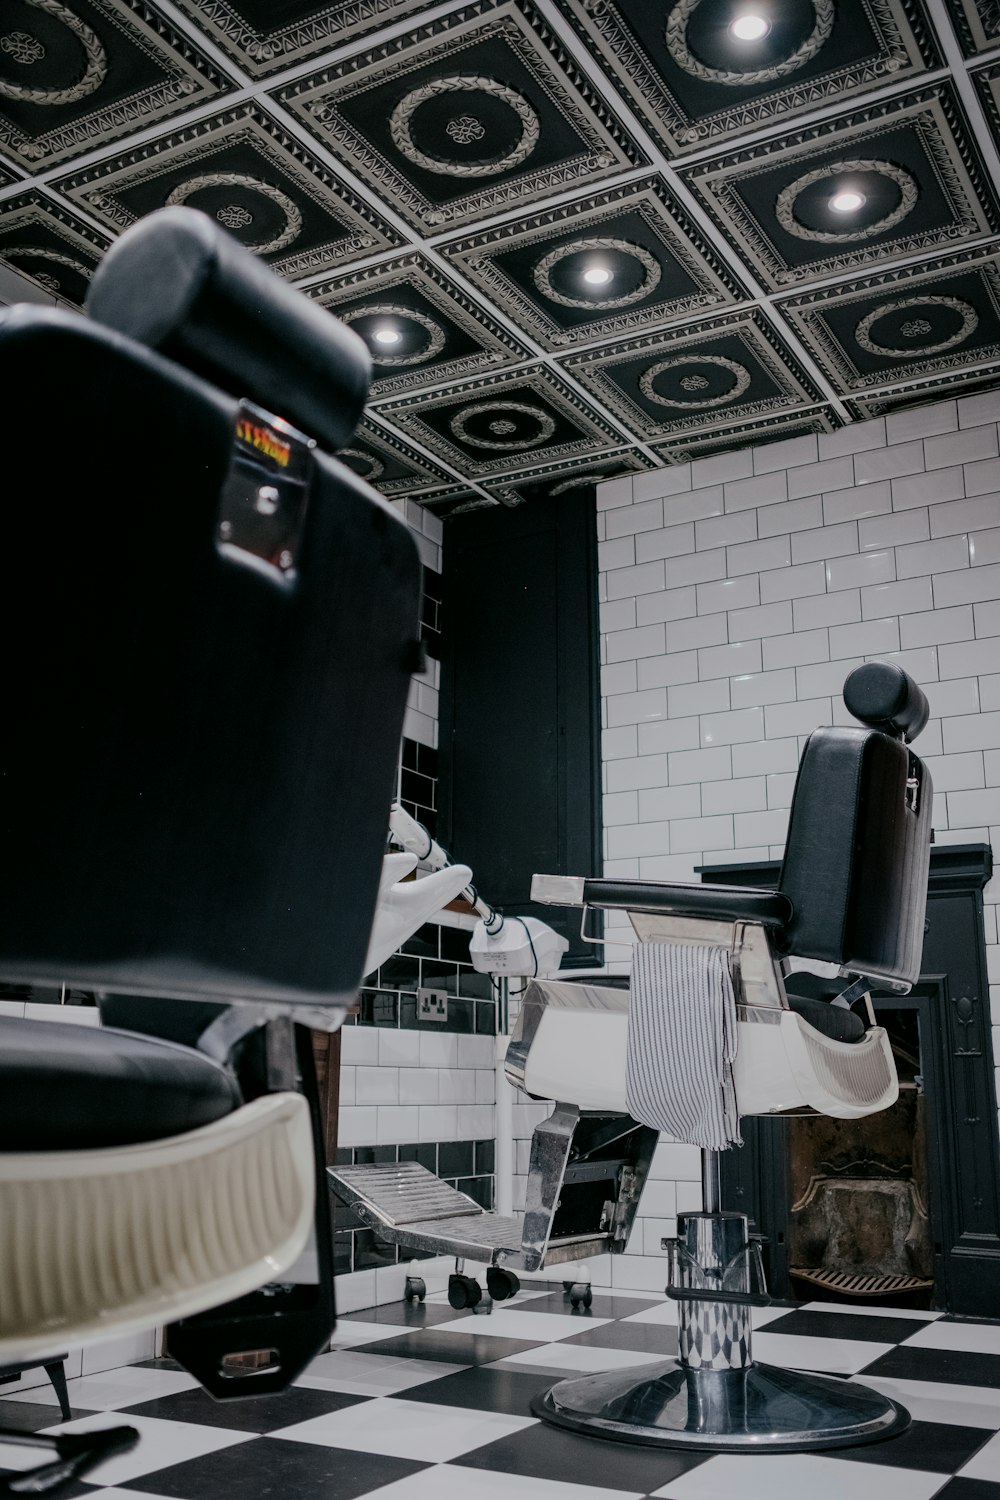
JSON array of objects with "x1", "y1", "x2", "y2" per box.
[{"x1": 531, "y1": 875, "x2": 792, "y2": 929}]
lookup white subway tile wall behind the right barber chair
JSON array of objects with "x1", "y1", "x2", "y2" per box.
[{"x1": 594, "y1": 393, "x2": 1000, "y2": 1290}]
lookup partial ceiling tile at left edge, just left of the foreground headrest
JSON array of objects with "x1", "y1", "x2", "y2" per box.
[{"x1": 0, "y1": 189, "x2": 108, "y2": 308}]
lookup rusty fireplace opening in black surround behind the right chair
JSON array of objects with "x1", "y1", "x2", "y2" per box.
[{"x1": 789, "y1": 1001, "x2": 934, "y2": 1308}]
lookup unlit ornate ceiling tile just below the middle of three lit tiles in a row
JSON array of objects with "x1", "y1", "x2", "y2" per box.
[{"x1": 562, "y1": 309, "x2": 819, "y2": 441}]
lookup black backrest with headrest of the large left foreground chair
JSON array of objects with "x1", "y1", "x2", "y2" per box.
[{"x1": 0, "y1": 210, "x2": 420, "y2": 1014}]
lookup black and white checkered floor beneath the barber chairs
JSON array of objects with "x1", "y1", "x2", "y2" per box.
[{"x1": 0, "y1": 1284, "x2": 1000, "y2": 1500}]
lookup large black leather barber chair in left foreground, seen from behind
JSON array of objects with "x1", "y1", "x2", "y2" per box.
[{"x1": 0, "y1": 209, "x2": 420, "y2": 1488}]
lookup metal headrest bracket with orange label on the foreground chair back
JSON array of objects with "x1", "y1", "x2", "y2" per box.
[{"x1": 217, "y1": 401, "x2": 315, "y2": 581}]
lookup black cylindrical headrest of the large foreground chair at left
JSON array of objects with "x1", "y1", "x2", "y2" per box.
[{"x1": 87, "y1": 207, "x2": 372, "y2": 452}]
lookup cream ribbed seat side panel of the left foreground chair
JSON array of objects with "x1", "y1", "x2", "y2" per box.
[{"x1": 0, "y1": 1094, "x2": 316, "y2": 1365}]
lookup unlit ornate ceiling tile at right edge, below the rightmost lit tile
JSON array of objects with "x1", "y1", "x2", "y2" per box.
[{"x1": 783, "y1": 246, "x2": 1000, "y2": 395}]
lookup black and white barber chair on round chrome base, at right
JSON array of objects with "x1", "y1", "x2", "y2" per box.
[{"x1": 527, "y1": 663, "x2": 933, "y2": 1452}]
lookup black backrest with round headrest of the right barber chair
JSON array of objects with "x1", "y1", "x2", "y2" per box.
[{"x1": 780, "y1": 662, "x2": 933, "y2": 987}]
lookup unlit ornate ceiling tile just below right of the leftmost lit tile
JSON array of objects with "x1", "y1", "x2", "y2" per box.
[{"x1": 379, "y1": 366, "x2": 625, "y2": 480}]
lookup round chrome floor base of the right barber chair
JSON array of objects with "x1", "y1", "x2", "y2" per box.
[{"x1": 531, "y1": 1359, "x2": 910, "y2": 1454}]
